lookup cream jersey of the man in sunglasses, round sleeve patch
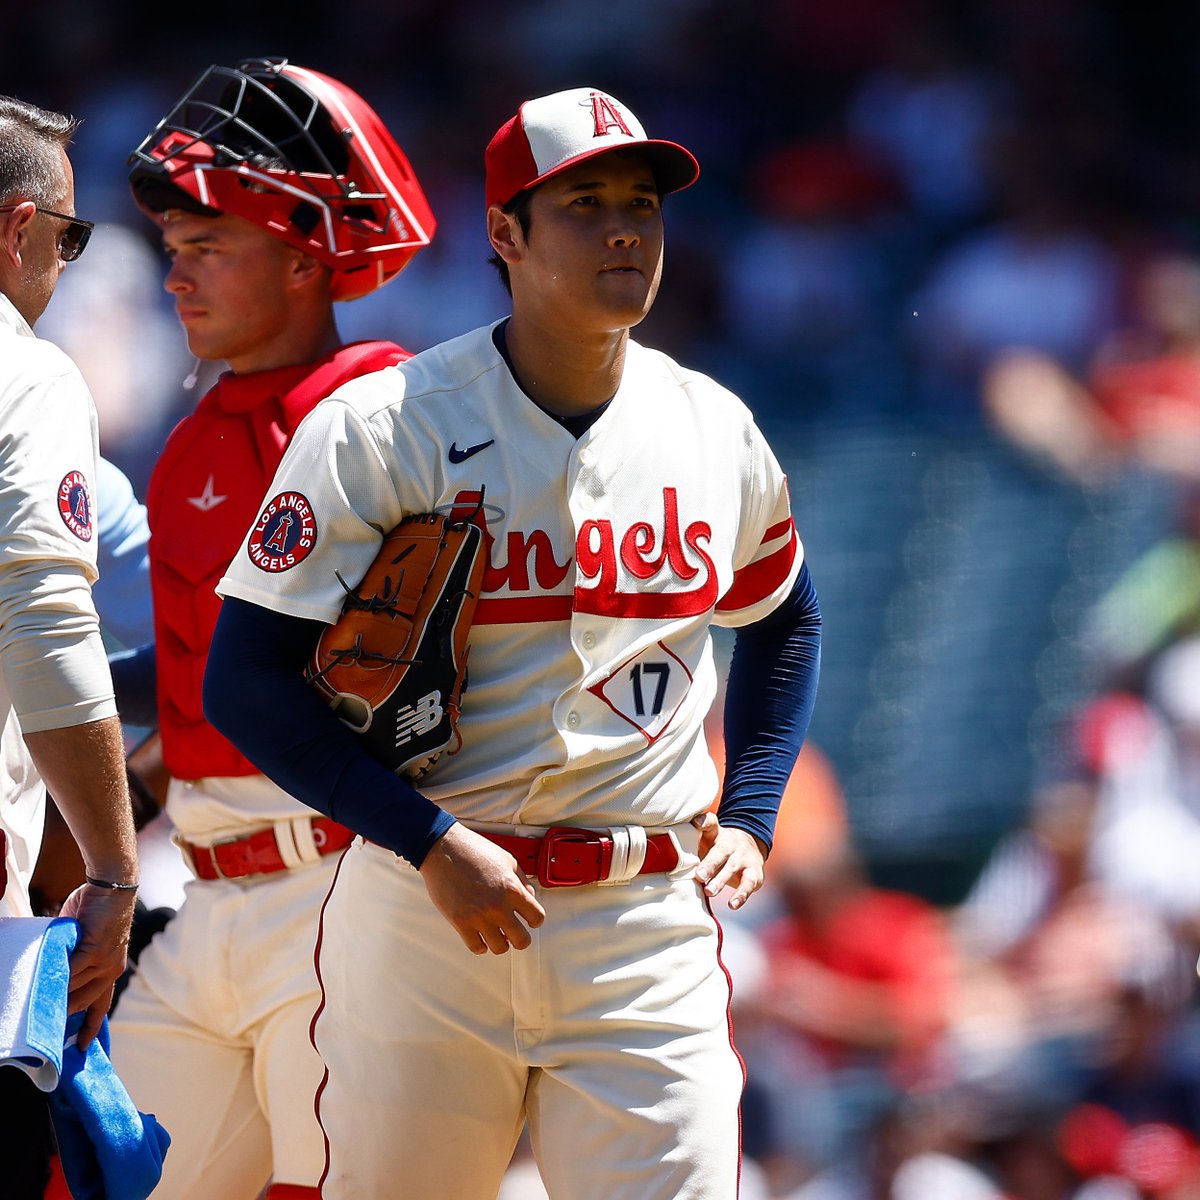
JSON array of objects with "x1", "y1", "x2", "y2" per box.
[{"x1": 0, "y1": 295, "x2": 116, "y2": 916}]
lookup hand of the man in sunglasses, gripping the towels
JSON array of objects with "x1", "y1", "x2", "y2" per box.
[{"x1": 61, "y1": 883, "x2": 137, "y2": 1050}]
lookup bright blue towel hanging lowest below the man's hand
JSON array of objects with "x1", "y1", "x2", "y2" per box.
[{"x1": 49, "y1": 1013, "x2": 170, "y2": 1200}]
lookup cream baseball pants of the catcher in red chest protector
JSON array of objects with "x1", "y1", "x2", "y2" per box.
[{"x1": 110, "y1": 856, "x2": 337, "y2": 1200}]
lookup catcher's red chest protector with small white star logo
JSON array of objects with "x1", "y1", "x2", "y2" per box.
[{"x1": 146, "y1": 342, "x2": 409, "y2": 779}]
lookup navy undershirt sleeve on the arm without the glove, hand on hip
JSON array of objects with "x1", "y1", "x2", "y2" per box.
[{"x1": 716, "y1": 563, "x2": 821, "y2": 848}]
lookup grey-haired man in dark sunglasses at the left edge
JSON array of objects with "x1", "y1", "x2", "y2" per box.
[{"x1": 0, "y1": 96, "x2": 138, "y2": 1196}]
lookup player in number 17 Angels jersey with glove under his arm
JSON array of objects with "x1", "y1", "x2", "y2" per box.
[{"x1": 205, "y1": 88, "x2": 820, "y2": 1200}]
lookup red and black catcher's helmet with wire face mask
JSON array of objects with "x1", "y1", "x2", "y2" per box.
[{"x1": 128, "y1": 59, "x2": 437, "y2": 300}]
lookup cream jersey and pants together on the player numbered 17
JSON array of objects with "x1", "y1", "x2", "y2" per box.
[{"x1": 218, "y1": 329, "x2": 803, "y2": 1200}]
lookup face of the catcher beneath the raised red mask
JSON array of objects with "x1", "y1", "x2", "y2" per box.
[{"x1": 162, "y1": 210, "x2": 316, "y2": 373}]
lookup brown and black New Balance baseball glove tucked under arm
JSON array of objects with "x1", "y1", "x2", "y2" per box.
[{"x1": 305, "y1": 512, "x2": 485, "y2": 780}]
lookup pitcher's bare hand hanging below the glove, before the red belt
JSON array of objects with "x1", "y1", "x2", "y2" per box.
[{"x1": 421, "y1": 822, "x2": 546, "y2": 954}]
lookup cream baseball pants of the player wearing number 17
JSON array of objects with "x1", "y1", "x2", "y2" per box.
[{"x1": 313, "y1": 839, "x2": 744, "y2": 1200}]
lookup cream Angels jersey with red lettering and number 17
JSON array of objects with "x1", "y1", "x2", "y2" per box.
[{"x1": 217, "y1": 326, "x2": 803, "y2": 826}]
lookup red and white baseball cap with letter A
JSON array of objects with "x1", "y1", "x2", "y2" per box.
[{"x1": 484, "y1": 88, "x2": 700, "y2": 208}]
